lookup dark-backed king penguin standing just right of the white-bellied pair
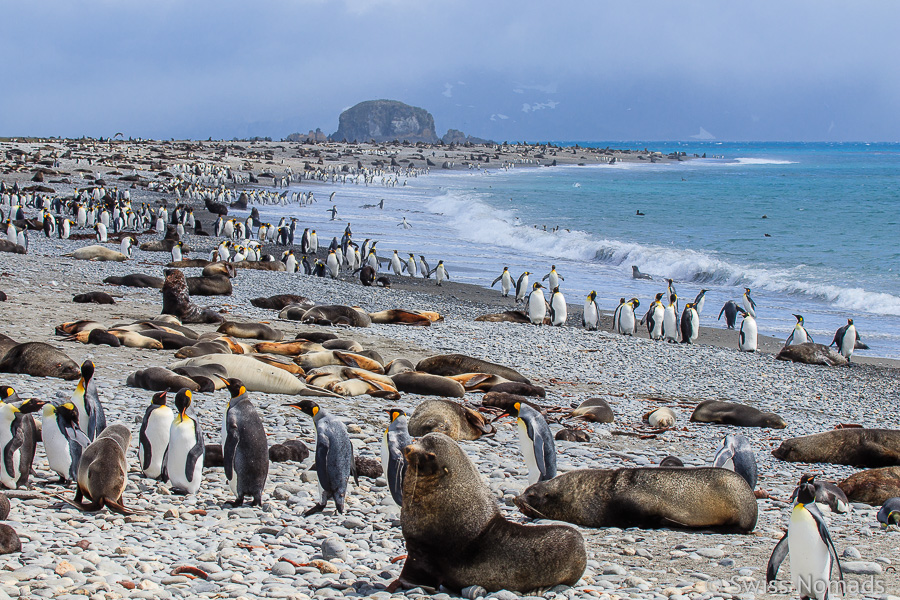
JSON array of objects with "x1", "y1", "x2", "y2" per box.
[{"x1": 219, "y1": 377, "x2": 269, "y2": 506}]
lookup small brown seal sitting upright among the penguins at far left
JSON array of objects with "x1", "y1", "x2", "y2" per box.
[{"x1": 75, "y1": 423, "x2": 131, "y2": 513}]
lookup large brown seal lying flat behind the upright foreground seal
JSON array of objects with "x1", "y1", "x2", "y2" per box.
[{"x1": 514, "y1": 467, "x2": 757, "y2": 533}]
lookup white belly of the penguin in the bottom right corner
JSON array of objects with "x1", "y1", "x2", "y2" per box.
[{"x1": 788, "y1": 508, "x2": 831, "y2": 600}]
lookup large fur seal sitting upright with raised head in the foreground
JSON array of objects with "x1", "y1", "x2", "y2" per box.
[{"x1": 398, "y1": 433, "x2": 587, "y2": 592}]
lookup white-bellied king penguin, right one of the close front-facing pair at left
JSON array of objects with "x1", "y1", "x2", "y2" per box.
[{"x1": 165, "y1": 388, "x2": 204, "y2": 494}]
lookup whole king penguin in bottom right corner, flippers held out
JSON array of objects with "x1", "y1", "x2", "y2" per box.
[{"x1": 766, "y1": 483, "x2": 844, "y2": 600}]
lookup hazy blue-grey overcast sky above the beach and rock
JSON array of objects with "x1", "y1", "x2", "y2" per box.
[{"x1": 0, "y1": 0, "x2": 900, "y2": 141}]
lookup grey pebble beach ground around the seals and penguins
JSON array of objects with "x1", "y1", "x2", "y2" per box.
[{"x1": 0, "y1": 142, "x2": 900, "y2": 600}]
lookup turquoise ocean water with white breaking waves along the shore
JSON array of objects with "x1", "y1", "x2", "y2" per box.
[{"x1": 243, "y1": 142, "x2": 900, "y2": 358}]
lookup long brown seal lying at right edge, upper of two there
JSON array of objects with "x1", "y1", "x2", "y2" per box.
[{"x1": 772, "y1": 429, "x2": 900, "y2": 466}]
